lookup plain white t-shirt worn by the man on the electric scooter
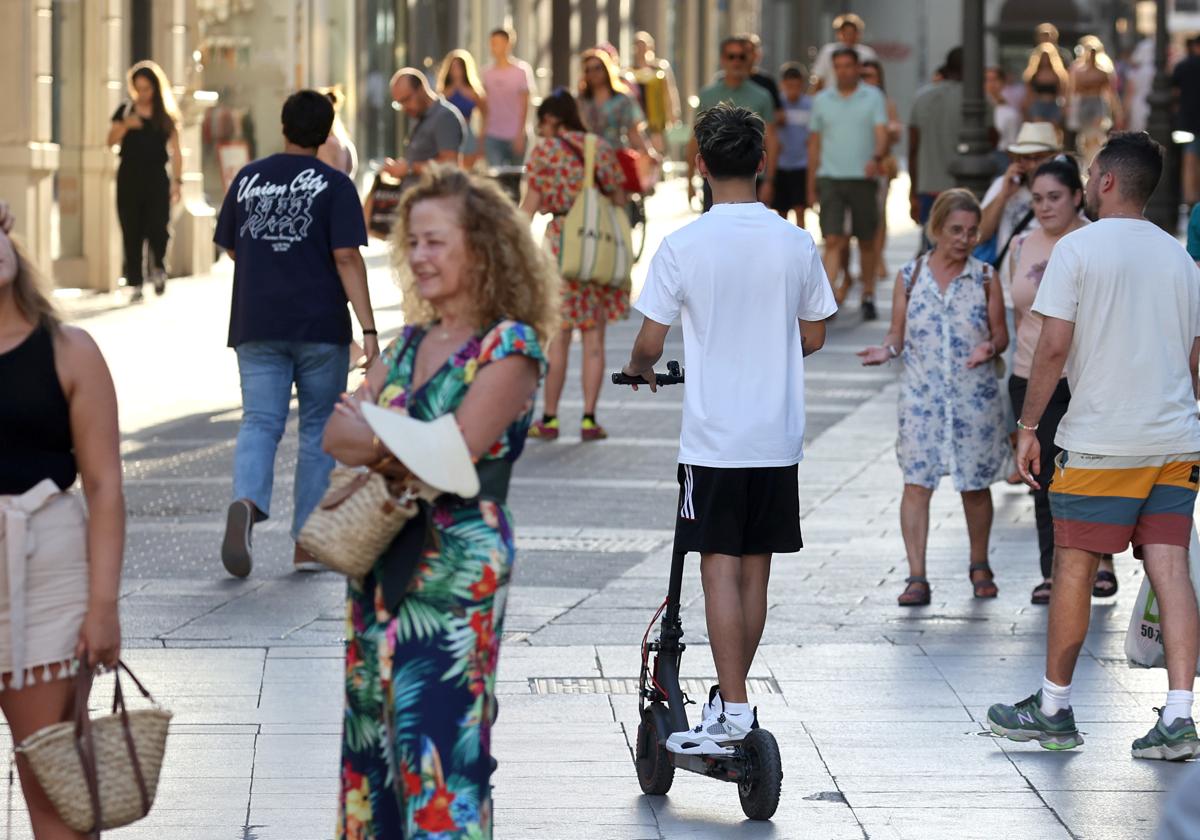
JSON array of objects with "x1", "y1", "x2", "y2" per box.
[{"x1": 635, "y1": 203, "x2": 838, "y2": 468}]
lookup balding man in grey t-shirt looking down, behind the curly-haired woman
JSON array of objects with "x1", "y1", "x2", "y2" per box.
[{"x1": 383, "y1": 67, "x2": 467, "y2": 190}]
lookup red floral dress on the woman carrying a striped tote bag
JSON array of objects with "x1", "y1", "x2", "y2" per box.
[{"x1": 526, "y1": 131, "x2": 629, "y2": 330}]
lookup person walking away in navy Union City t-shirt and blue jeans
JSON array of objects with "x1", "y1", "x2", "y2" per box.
[{"x1": 214, "y1": 90, "x2": 379, "y2": 577}]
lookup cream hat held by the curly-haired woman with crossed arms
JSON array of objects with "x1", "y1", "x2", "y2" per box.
[{"x1": 362, "y1": 402, "x2": 479, "y2": 499}]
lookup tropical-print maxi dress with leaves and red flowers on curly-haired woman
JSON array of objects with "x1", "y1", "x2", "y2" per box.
[{"x1": 337, "y1": 320, "x2": 545, "y2": 840}]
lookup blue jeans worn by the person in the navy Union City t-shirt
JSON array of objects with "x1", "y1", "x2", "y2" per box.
[{"x1": 233, "y1": 341, "x2": 350, "y2": 539}]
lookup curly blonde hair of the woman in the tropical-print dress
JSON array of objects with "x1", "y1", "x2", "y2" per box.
[{"x1": 391, "y1": 164, "x2": 562, "y2": 347}]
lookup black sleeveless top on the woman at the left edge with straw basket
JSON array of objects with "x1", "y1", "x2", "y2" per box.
[{"x1": 0, "y1": 326, "x2": 78, "y2": 496}]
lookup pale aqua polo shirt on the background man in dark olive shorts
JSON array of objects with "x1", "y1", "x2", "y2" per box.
[{"x1": 809, "y1": 84, "x2": 888, "y2": 179}]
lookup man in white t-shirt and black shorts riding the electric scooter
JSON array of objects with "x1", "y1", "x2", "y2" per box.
[{"x1": 625, "y1": 102, "x2": 838, "y2": 755}]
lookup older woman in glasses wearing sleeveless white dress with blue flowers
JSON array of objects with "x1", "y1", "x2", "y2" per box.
[{"x1": 858, "y1": 190, "x2": 1012, "y2": 606}]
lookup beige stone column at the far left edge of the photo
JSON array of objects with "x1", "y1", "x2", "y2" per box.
[{"x1": 0, "y1": 0, "x2": 59, "y2": 272}]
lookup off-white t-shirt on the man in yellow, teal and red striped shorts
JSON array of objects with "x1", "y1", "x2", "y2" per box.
[{"x1": 1033, "y1": 218, "x2": 1200, "y2": 455}]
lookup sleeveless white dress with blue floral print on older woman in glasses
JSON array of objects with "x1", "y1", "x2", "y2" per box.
[{"x1": 896, "y1": 257, "x2": 1012, "y2": 492}]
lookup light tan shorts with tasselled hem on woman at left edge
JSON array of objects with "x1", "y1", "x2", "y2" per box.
[{"x1": 0, "y1": 479, "x2": 88, "y2": 689}]
